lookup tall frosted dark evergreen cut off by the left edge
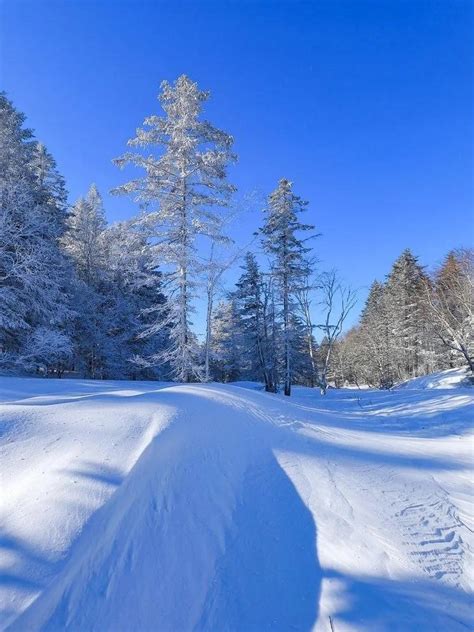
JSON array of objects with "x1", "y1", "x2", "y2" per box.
[{"x1": 0, "y1": 94, "x2": 71, "y2": 371}]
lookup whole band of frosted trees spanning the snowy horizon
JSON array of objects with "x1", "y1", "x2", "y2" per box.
[{"x1": 0, "y1": 75, "x2": 473, "y2": 395}]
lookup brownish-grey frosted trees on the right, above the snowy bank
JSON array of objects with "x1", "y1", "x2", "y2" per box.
[{"x1": 332, "y1": 249, "x2": 474, "y2": 388}]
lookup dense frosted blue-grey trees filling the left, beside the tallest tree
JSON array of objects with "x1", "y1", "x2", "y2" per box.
[{"x1": 0, "y1": 95, "x2": 165, "y2": 378}]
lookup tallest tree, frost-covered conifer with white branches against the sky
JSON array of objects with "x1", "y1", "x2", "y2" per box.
[{"x1": 114, "y1": 75, "x2": 235, "y2": 382}]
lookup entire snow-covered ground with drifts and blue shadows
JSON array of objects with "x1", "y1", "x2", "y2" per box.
[{"x1": 0, "y1": 374, "x2": 474, "y2": 632}]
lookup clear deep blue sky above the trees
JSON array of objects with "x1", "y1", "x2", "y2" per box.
[{"x1": 0, "y1": 0, "x2": 474, "y2": 334}]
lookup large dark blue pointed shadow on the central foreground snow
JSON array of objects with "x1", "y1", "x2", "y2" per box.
[{"x1": 196, "y1": 452, "x2": 321, "y2": 632}]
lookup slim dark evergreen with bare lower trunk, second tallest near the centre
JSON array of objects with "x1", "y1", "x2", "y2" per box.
[{"x1": 262, "y1": 179, "x2": 313, "y2": 395}]
